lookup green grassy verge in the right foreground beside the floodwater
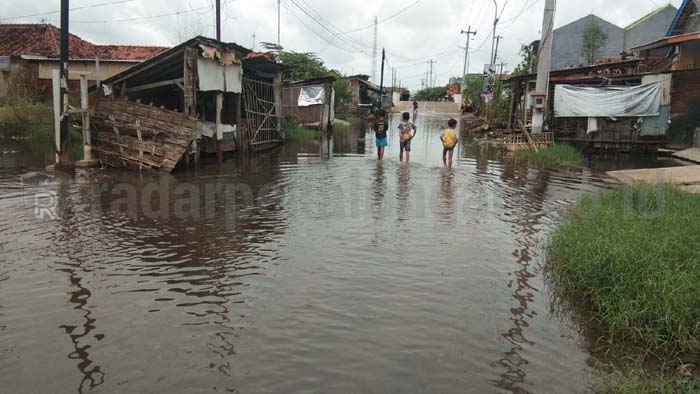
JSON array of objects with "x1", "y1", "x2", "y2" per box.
[{"x1": 548, "y1": 185, "x2": 700, "y2": 393}]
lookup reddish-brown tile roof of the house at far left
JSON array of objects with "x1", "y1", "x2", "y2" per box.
[{"x1": 0, "y1": 24, "x2": 168, "y2": 61}]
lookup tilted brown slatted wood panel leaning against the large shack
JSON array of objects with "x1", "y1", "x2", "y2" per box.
[{"x1": 92, "y1": 99, "x2": 198, "y2": 172}]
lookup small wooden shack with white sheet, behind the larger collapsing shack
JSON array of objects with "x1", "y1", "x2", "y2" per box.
[{"x1": 282, "y1": 76, "x2": 336, "y2": 131}]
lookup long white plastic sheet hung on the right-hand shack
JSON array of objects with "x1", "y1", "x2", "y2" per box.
[{"x1": 554, "y1": 82, "x2": 661, "y2": 118}]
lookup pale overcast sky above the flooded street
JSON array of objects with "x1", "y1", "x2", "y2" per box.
[{"x1": 0, "y1": 0, "x2": 680, "y2": 90}]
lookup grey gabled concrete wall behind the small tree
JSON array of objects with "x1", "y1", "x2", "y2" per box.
[{"x1": 551, "y1": 14, "x2": 624, "y2": 70}]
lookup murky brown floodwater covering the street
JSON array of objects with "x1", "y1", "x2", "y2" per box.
[{"x1": 0, "y1": 114, "x2": 680, "y2": 393}]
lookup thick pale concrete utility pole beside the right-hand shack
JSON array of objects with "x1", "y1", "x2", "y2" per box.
[{"x1": 532, "y1": 0, "x2": 556, "y2": 133}]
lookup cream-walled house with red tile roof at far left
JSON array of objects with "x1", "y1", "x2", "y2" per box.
[{"x1": 0, "y1": 24, "x2": 168, "y2": 99}]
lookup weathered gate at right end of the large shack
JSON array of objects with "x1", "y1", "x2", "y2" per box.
[{"x1": 241, "y1": 78, "x2": 284, "y2": 150}]
